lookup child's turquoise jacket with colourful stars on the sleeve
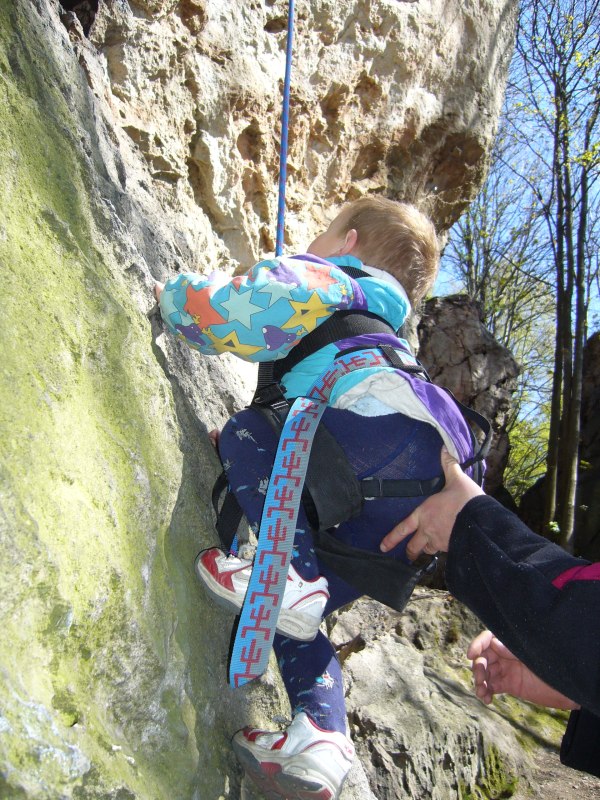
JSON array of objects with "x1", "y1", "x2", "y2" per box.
[{"x1": 160, "y1": 255, "x2": 410, "y2": 404}]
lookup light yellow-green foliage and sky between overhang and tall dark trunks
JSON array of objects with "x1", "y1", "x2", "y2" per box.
[{"x1": 443, "y1": 130, "x2": 554, "y2": 497}]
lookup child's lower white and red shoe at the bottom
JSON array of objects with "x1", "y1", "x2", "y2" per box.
[{"x1": 232, "y1": 712, "x2": 354, "y2": 800}]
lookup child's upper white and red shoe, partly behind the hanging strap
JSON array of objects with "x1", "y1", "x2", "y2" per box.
[{"x1": 196, "y1": 547, "x2": 329, "y2": 642}]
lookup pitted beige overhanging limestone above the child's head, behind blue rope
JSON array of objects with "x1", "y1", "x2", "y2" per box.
[{"x1": 82, "y1": 0, "x2": 516, "y2": 267}]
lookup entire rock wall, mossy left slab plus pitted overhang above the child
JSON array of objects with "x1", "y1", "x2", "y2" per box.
[{"x1": 0, "y1": 0, "x2": 516, "y2": 800}]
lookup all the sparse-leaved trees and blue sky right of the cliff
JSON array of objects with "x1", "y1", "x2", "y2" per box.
[{"x1": 438, "y1": 0, "x2": 600, "y2": 524}]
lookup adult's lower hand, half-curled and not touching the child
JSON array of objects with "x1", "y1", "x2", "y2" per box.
[{"x1": 467, "y1": 631, "x2": 579, "y2": 710}]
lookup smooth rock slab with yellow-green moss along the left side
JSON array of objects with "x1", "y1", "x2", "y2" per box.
[{"x1": 0, "y1": 0, "x2": 237, "y2": 800}]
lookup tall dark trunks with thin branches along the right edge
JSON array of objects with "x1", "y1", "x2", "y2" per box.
[{"x1": 507, "y1": 0, "x2": 600, "y2": 549}]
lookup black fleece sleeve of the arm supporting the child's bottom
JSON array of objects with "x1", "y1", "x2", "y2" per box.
[{"x1": 446, "y1": 496, "x2": 600, "y2": 717}]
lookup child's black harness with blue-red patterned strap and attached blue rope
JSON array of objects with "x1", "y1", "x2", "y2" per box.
[{"x1": 213, "y1": 0, "x2": 491, "y2": 687}]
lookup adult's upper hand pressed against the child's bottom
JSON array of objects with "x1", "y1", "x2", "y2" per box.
[{"x1": 379, "y1": 447, "x2": 483, "y2": 560}]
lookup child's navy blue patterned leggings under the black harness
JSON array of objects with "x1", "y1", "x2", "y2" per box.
[{"x1": 219, "y1": 408, "x2": 442, "y2": 733}]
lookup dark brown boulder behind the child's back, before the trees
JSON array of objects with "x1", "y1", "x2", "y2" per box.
[{"x1": 418, "y1": 295, "x2": 519, "y2": 494}]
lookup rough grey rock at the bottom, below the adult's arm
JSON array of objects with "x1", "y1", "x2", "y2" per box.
[{"x1": 331, "y1": 588, "x2": 562, "y2": 800}]
